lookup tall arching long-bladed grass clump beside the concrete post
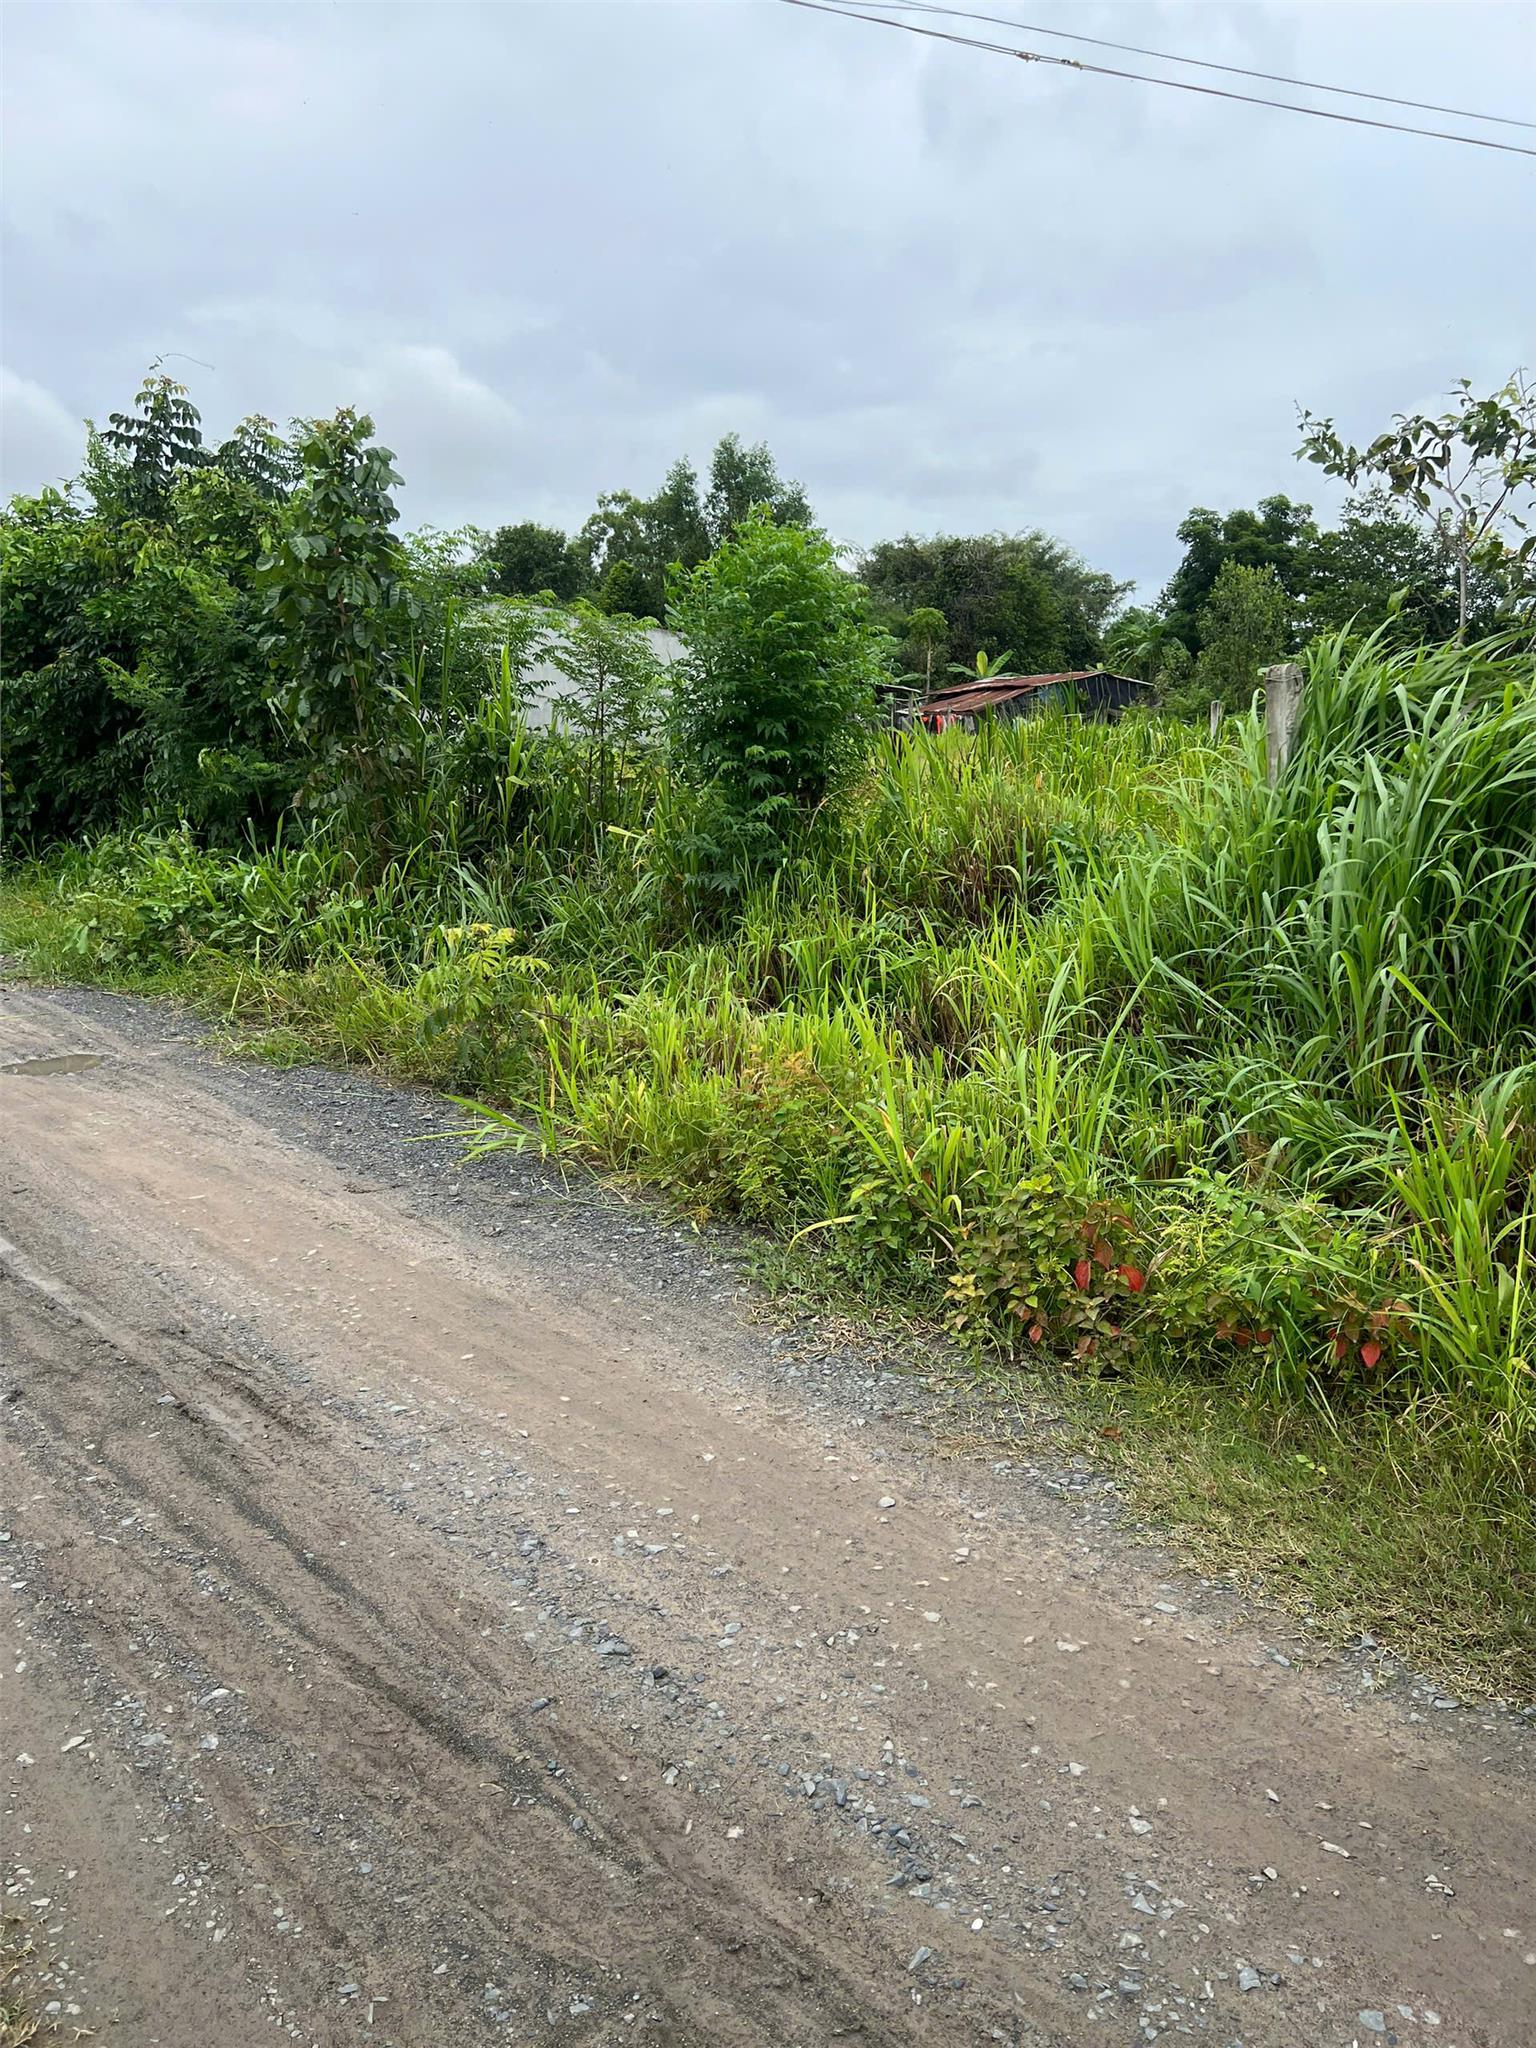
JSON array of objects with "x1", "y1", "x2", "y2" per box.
[{"x1": 1104, "y1": 639, "x2": 1536, "y2": 1112}]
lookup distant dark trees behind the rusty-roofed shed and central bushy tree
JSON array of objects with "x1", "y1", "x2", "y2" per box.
[{"x1": 481, "y1": 375, "x2": 1536, "y2": 715}]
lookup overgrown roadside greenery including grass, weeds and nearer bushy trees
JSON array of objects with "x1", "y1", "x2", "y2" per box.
[{"x1": 4, "y1": 364, "x2": 1536, "y2": 1690}]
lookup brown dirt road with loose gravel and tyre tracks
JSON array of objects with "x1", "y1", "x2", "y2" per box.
[{"x1": 0, "y1": 985, "x2": 1536, "y2": 2048}]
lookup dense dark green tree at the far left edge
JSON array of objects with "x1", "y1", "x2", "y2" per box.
[{"x1": 0, "y1": 375, "x2": 295, "y2": 844}]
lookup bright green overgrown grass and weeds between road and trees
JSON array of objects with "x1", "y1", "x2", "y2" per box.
[{"x1": 0, "y1": 643, "x2": 1536, "y2": 1696}]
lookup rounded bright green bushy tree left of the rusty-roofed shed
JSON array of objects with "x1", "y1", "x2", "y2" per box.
[{"x1": 670, "y1": 504, "x2": 885, "y2": 883}]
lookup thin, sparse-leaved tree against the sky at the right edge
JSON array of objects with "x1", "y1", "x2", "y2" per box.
[{"x1": 1296, "y1": 371, "x2": 1536, "y2": 635}]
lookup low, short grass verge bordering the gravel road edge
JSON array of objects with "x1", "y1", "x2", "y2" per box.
[{"x1": 0, "y1": 872, "x2": 1536, "y2": 1703}]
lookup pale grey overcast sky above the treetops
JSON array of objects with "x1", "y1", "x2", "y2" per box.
[{"x1": 2, "y1": 0, "x2": 1536, "y2": 586}]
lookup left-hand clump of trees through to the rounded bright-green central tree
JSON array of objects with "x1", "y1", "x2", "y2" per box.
[{"x1": 0, "y1": 367, "x2": 889, "y2": 880}]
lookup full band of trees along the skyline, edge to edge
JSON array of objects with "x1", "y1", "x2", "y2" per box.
[{"x1": 0, "y1": 369, "x2": 1536, "y2": 842}]
